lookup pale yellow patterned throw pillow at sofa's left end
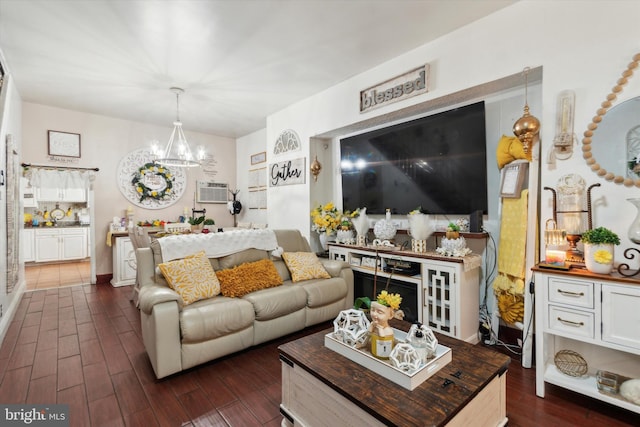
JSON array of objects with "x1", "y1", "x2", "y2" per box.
[{"x1": 158, "y1": 251, "x2": 220, "y2": 305}]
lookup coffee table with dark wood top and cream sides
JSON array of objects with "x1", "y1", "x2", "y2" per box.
[{"x1": 278, "y1": 322, "x2": 511, "y2": 427}]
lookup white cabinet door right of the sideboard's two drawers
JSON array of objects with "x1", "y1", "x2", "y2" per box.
[{"x1": 602, "y1": 284, "x2": 640, "y2": 350}]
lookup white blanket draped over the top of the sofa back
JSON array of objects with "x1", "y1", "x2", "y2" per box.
[{"x1": 158, "y1": 229, "x2": 278, "y2": 262}]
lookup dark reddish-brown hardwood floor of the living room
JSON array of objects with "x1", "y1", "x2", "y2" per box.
[{"x1": 0, "y1": 284, "x2": 640, "y2": 427}]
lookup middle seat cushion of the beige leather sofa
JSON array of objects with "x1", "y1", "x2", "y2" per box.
[{"x1": 242, "y1": 282, "x2": 307, "y2": 321}]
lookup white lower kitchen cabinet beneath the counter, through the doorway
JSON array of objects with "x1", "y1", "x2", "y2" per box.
[{"x1": 35, "y1": 227, "x2": 88, "y2": 262}]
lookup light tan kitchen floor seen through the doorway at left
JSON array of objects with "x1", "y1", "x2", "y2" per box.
[{"x1": 24, "y1": 259, "x2": 91, "y2": 291}]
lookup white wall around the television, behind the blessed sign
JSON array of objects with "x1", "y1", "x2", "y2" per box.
[{"x1": 267, "y1": 0, "x2": 640, "y2": 270}]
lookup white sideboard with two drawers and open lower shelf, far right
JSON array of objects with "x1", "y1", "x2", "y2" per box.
[{"x1": 534, "y1": 267, "x2": 640, "y2": 413}]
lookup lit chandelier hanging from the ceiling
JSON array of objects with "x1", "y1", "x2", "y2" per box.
[{"x1": 151, "y1": 87, "x2": 205, "y2": 168}]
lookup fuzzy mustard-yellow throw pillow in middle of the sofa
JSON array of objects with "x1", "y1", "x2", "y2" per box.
[{"x1": 216, "y1": 259, "x2": 282, "y2": 297}]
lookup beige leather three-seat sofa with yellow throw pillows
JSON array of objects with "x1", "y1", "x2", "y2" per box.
[{"x1": 136, "y1": 230, "x2": 353, "y2": 378}]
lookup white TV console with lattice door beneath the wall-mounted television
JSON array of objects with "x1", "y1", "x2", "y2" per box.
[{"x1": 329, "y1": 244, "x2": 480, "y2": 344}]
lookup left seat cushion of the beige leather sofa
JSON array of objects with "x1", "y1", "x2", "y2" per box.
[{"x1": 180, "y1": 295, "x2": 254, "y2": 343}]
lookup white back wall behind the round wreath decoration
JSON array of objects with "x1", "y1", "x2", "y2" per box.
[{"x1": 21, "y1": 102, "x2": 236, "y2": 276}]
